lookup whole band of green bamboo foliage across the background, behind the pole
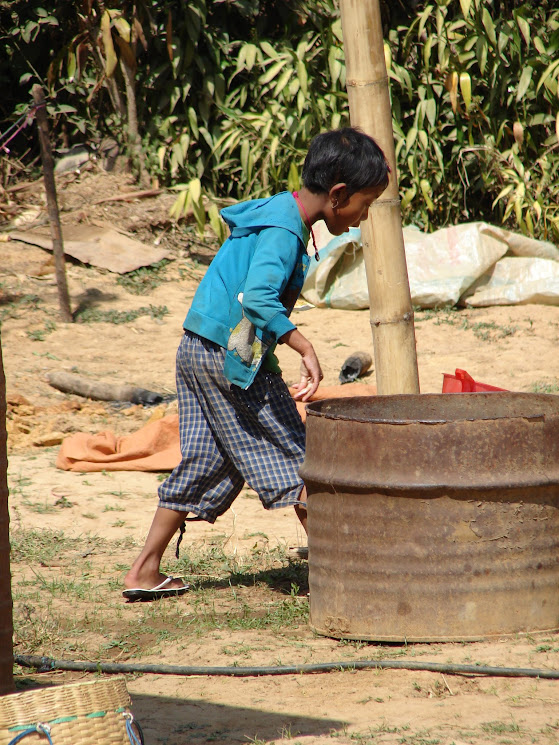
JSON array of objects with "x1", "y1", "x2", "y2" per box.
[{"x1": 4, "y1": 0, "x2": 559, "y2": 241}]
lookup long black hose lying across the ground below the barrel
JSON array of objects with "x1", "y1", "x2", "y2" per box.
[{"x1": 14, "y1": 655, "x2": 559, "y2": 680}]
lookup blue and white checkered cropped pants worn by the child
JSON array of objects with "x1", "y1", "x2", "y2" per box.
[{"x1": 159, "y1": 331, "x2": 305, "y2": 523}]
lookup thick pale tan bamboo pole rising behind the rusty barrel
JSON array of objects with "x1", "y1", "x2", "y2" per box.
[{"x1": 340, "y1": 0, "x2": 419, "y2": 394}]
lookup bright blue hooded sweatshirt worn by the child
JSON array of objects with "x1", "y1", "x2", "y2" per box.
[{"x1": 184, "y1": 192, "x2": 309, "y2": 389}]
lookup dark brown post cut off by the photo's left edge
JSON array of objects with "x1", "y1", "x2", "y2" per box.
[{"x1": 0, "y1": 331, "x2": 14, "y2": 695}]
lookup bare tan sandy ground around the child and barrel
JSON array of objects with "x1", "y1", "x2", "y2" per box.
[{"x1": 0, "y1": 169, "x2": 559, "y2": 745}]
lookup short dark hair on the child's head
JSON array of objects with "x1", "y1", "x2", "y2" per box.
[{"x1": 302, "y1": 127, "x2": 390, "y2": 195}]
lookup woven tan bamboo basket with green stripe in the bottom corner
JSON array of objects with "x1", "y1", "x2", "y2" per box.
[{"x1": 0, "y1": 677, "x2": 142, "y2": 745}]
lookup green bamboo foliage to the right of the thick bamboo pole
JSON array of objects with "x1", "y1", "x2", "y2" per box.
[{"x1": 389, "y1": 0, "x2": 559, "y2": 240}]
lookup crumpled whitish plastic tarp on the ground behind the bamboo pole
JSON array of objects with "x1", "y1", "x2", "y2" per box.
[{"x1": 302, "y1": 222, "x2": 559, "y2": 310}]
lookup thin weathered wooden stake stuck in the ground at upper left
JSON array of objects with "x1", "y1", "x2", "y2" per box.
[{"x1": 31, "y1": 85, "x2": 73, "y2": 323}]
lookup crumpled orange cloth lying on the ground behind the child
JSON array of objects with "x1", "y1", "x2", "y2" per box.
[{"x1": 56, "y1": 383, "x2": 376, "y2": 473}]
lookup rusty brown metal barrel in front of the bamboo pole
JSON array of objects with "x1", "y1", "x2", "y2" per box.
[{"x1": 301, "y1": 393, "x2": 559, "y2": 641}]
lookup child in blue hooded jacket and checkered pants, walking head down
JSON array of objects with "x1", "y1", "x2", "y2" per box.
[{"x1": 123, "y1": 127, "x2": 390, "y2": 600}]
